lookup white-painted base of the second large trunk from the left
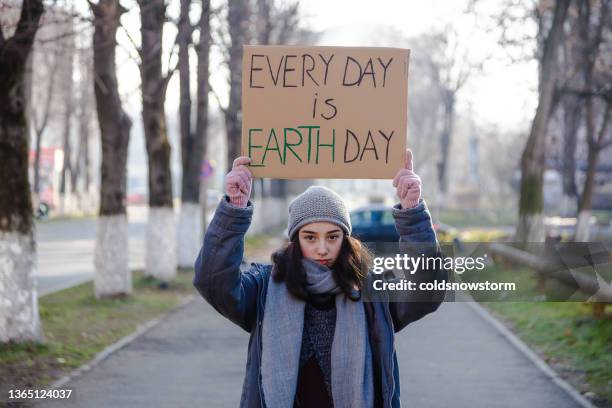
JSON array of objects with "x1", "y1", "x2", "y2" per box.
[{"x1": 94, "y1": 214, "x2": 132, "y2": 298}]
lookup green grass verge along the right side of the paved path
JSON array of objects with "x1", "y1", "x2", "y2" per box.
[{"x1": 462, "y1": 260, "x2": 612, "y2": 408}]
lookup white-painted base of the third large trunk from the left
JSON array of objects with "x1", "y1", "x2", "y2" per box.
[{"x1": 145, "y1": 207, "x2": 177, "y2": 281}]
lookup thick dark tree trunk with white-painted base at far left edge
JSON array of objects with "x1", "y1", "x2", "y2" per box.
[{"x1": 0, "y1": 0, "x2": 44, "y2": 342}]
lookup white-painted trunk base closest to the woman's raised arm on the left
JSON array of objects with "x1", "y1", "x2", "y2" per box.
[{"x1": 177, "y1": 203, "x2": 202, "y2": 268}]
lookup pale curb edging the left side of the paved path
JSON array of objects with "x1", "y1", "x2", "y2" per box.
[{"x1": 47, "y1": 295, "x2": 197, "y2": 390}]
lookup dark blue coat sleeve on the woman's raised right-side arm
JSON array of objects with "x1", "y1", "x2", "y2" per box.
[{"x1": 389, "y1": 199, "x2": 448, "y2": 332}]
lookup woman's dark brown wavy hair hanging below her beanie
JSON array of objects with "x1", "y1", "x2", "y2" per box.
[{"x1": 271, "y1": 233, "x2": 372, "y2": 301}]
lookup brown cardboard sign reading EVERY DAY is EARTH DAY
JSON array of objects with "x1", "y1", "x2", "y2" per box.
[{"x1": 242, "y1": 46, "x2": 410, "y2": 179}]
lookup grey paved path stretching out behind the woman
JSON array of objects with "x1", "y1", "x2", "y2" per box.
[{"x1": 41, "y1": 298, "x2": 578, "y2": 408}]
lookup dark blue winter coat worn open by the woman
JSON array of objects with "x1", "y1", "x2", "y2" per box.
[{"x1": 193, "y1": 197, "x2": 447, "y2": 408}]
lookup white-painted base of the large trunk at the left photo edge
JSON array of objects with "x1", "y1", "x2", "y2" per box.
[{"x1": 0, "y1": 231, "x2": 43, "y2": 343}]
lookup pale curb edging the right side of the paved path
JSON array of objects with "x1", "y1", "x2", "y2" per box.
[{"x1": 466, "y1": 301, "x2": 597, "y2": 408}]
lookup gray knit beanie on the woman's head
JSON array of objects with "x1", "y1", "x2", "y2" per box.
[{"x1": 287, "y1": 186, "x2": 351, "y2": 239}]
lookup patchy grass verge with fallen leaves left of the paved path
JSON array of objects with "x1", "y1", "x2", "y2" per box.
[{"x1": 0, "y1": 270, "x2": 194, "y2": 401}]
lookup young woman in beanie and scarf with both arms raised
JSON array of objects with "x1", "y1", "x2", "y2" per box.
[{"x1": 193, "y1": 150, "x2": 447, "y2": 408}]
